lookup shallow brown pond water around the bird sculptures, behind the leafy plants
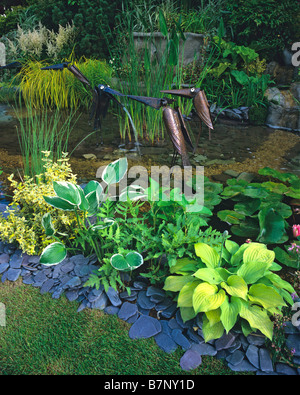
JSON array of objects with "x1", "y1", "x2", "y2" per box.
[{"x1": 0, "y1": 105, "x2": 300, "y2": 186}]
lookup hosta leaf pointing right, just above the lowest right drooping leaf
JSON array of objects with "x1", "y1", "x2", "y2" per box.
[{"x1": 248, "y1": 284, "x2": 286, "y2": 309}]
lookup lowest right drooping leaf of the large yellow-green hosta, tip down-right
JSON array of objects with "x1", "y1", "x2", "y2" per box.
[{"x1": 239, "y1": 299, "x2": 273, "y2": 340}]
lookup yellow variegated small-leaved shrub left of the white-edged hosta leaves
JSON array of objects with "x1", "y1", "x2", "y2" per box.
[{"x1": 0, "y1": 152, "x2": 76, "y2": 255}]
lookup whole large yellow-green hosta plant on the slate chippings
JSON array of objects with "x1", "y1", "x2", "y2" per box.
[{"x1": 164, "y1": 240, "x2": 294, "y2": 342}]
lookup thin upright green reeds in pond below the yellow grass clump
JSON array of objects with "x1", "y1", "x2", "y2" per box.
[{"x1": 15, "y1": 98, "x2": 77, "y2": 177}]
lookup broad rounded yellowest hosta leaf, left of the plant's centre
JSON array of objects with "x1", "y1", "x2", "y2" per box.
[{"x1": 193, "y1": 283, "x2": 225, "y2": 313}]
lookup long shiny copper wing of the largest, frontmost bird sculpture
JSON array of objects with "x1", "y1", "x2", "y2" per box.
[{"x1": 163, "y1": 107, "x2": 190, "y2": 166}]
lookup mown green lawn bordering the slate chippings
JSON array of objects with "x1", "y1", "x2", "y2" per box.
[{"x1": 0, "y1": 280, "x2": 253, "y2": 375}]
